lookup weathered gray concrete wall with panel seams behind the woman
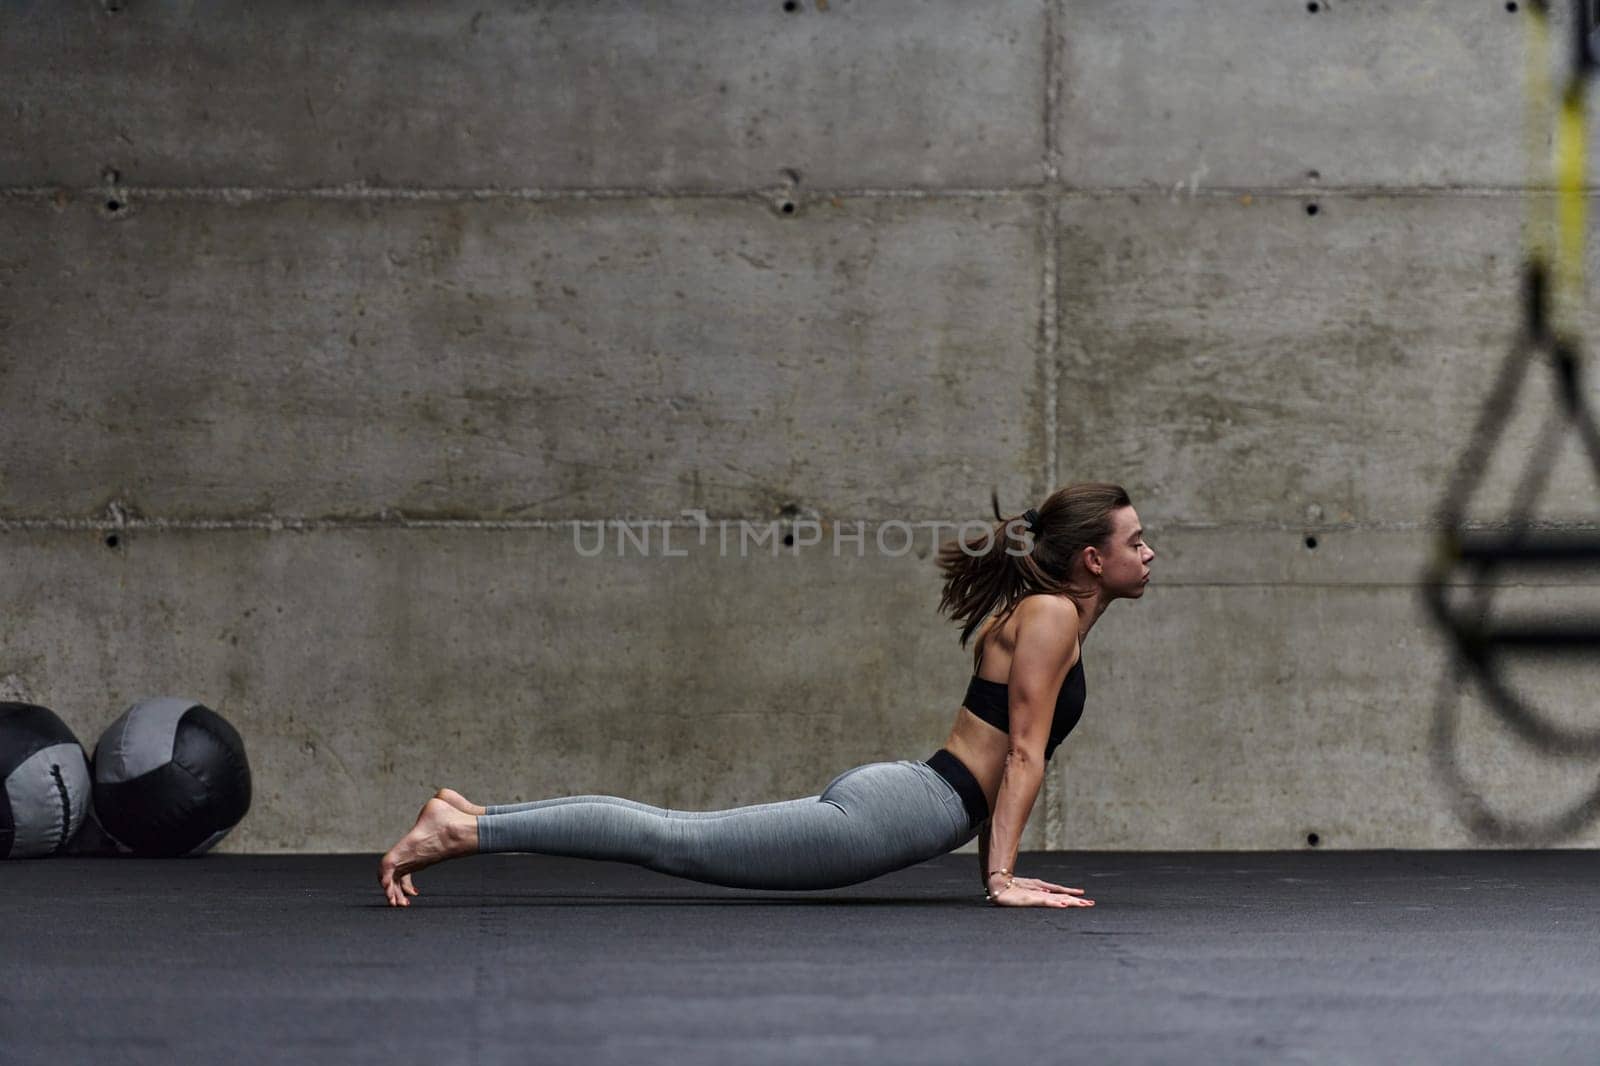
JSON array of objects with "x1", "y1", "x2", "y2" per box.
[{"x1": 0, "y1": 0, "x2": 1600, "y2": 845}]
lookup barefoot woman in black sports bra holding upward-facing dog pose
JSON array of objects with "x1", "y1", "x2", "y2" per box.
[{"x1": 378, "y1": 482, "x2": 1155, "y2": 908}]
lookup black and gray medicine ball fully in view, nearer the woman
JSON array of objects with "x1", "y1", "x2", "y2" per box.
[{"x1": 94, "y1": 698, "x2": 250, "y2": 858}]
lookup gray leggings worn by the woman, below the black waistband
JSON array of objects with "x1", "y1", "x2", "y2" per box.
[{"x1": 478, "y1": 759, "x2": 978, "y2": 888}]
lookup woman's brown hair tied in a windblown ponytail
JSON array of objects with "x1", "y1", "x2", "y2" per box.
[{"x1": 938, "y1": 482, "x2": 1133, "y2": 669}]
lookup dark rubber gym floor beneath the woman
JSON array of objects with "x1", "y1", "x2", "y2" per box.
[{"x1": 0, "y1": 850, "x2": 1600, "y2": 1066}]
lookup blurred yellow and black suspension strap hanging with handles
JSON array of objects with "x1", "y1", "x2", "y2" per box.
[{"x1": 1422, "y1": 0, "x2": 1600, "y2": 842}]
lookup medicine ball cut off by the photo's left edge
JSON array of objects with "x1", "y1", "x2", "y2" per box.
[{"x1": 0, "y1": 703, "x2": 91, "y2": 858}]
